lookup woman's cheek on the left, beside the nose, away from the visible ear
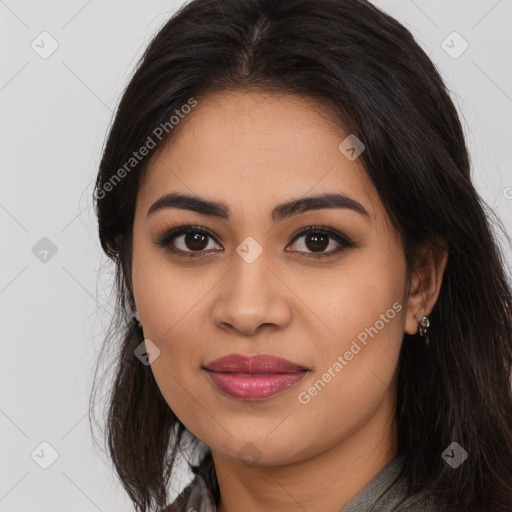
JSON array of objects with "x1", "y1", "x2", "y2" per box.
[{"x1": 132, "y1": 248, "x2": 213, "y2": 412}]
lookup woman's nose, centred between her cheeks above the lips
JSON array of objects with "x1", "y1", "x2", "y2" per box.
[{"x1": 212, "y1": 255, "x2": 291, "y2": 336}]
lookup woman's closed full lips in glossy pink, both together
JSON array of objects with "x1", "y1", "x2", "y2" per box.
[{"x1": 205, "y1": 354, "x2": 308, "y2": 400}]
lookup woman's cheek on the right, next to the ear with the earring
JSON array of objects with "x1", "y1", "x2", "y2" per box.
[{"x1": 301, "y1": 251, "x2": 405, "y2": 420}]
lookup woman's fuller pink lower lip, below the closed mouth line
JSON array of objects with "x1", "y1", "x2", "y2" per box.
[{"x1": 208, "y1": 370, "x2": 307, "y2": 400}]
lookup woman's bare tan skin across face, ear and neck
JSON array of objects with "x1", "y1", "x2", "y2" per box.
[{"x1": 132, "y1": 91, "x2": 446, "y2": 512}]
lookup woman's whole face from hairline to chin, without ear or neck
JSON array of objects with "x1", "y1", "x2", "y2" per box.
[{"x1": 132, "y1": 92, "x2": 407, "y2": 465}]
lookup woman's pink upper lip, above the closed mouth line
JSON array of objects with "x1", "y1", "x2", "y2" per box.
[{"x1": 205, "y1": 354, "x2": 307, "y2": 373}]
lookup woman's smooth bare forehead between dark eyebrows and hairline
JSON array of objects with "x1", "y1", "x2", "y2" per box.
[{"x1": 138, "y1": 91, "x2": 380, "y2": 222}]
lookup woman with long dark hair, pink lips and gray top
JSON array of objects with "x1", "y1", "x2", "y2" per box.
[{"x1": 90, "y1": 0, "x2": 512, "y2": 512}]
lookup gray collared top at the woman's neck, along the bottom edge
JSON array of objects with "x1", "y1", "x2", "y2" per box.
[{"x1": 161, "y1": 455, "x2": 441, "y2": 512}]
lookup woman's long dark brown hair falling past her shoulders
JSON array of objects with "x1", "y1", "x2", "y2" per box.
[{"x1": 91, "y1": 0, "x2": 512, "y2": 512}]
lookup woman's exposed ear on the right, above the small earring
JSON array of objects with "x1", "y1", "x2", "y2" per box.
[{"x1": 405, "y1": 239, "x2": 448, "y2": 334}]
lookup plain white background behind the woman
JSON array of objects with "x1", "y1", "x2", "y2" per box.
[{"x1": 0, "y1": 0, "x2": 512, "y2": 512}]
